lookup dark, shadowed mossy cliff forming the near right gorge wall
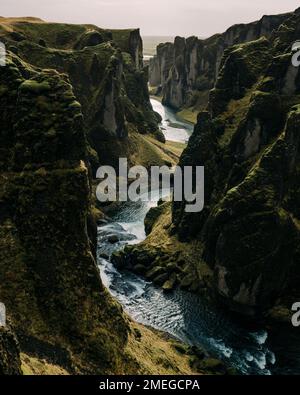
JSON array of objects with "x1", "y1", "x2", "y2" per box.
[{"x1": 173, "y1": 11, "x2": 300, "y2": 313}]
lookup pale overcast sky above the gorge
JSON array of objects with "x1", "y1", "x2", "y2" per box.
[{"x1": 0, "y1": 0, "x2": 300, "y2": 37}]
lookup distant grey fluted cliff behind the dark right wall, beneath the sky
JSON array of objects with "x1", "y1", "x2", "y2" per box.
[{"x1": 149, "y1": 14, "x2": 287, "y2": 111}]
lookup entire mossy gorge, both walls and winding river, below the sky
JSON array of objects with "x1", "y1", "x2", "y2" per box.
[{"x1": 0, "y1": 5, "x2": 300, "y2": 375}]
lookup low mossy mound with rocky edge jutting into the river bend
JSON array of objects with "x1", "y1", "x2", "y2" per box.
[{"x1": 113, "y1": 202, "x2": 212, "y2": 293}]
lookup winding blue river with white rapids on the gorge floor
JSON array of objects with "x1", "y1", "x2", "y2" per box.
[{"x1": 98, "y1": 100, "x2": 299, "y2": 375}]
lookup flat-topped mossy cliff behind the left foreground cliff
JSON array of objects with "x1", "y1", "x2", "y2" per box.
[{"x1": 0, "y1": 19, "x2": 158, "y2": 170}]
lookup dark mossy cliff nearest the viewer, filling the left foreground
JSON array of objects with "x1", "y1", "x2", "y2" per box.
[{"x1": 0, "y1": 53, "x2": 128, "y2": 373}]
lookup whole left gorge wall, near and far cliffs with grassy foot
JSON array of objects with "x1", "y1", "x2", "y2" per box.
[{"x1": 0, "y1": 18, "x2": 216, "y2": 374}]
